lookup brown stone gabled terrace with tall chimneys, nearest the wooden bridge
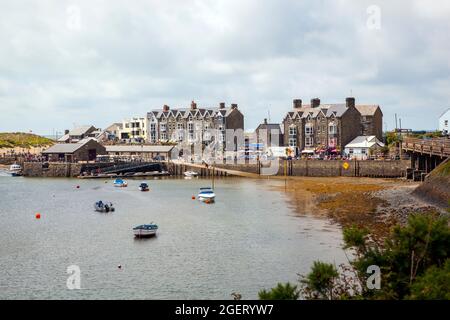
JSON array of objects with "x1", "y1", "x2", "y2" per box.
[{"x1": 283, "y1": 97, "x2": 383, "y2": 153}]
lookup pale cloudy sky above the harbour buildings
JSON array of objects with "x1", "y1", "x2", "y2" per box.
[{"x1": 0, "y1": 0, "x2": 450, "y2": 134}]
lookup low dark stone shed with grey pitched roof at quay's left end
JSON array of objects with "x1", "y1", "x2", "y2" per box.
[{"x1": 42, "y1": 139, "x2": 106, "y2": 162}]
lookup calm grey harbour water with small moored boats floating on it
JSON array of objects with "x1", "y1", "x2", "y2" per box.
[{"x1": 0, "y1": 174, "x2": 346, "y2": 299}]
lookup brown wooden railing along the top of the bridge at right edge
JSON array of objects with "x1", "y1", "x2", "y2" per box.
[{"x1": 402, "y1": 138, "x2": 450, "y2": 158}]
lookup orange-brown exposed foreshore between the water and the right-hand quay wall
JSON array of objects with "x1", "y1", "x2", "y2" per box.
[{"x1": 270, "y1": 177, "x2": 444, "y2": 238}]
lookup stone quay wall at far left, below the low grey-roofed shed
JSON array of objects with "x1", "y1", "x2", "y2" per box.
[{"x1": 23, "y1": 162, "x2": 82, "y2": 177}]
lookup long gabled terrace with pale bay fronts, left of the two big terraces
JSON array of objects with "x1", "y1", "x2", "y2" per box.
[{"x1": 147, "y1": 101, "x2": 244, "y2": 149}]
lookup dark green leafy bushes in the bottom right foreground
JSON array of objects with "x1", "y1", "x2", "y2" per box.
[{"x1": 266, "y1": 213, "x2": 450, "y2": 299}]
